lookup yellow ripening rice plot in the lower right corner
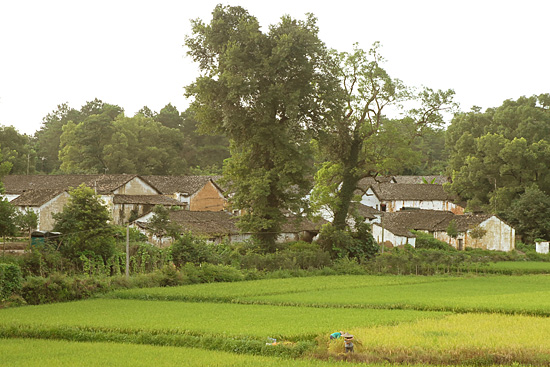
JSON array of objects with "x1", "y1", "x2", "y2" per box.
[{"x1": 336, "y1": 313, "x2": 550, "y2": 365}]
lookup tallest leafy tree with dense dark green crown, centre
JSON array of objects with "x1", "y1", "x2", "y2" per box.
[{"x1": 186, "y1": 5, "x2": 338, "y2": 249}]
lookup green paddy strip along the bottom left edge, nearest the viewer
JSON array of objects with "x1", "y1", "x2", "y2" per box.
[{"x1": 0, "y1": 339, "x2": 370, "y2": 367}]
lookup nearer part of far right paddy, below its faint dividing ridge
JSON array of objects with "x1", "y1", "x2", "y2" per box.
[{"x1": 240, "y1": 275, "x2": 550, "y2": 316}]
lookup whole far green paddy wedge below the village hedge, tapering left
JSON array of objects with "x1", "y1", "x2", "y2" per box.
[{"x1": 111, "y1": 275, "x2": 550, "y2": 316}]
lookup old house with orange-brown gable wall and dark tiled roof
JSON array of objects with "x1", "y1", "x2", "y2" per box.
[{"x1": 143, "y1": 176, "x2": 227, "y2": 211}]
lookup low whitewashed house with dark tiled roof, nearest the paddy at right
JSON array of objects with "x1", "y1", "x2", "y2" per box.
[{"x1": 372, "y1": 210, "x2": 515, "y2": 251}]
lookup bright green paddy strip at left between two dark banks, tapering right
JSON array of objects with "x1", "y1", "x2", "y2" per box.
[{"x1": 0, "y1": 299, "x2": 442, "y2": 344}]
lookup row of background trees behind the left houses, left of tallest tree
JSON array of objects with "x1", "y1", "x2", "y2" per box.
[{"x1": 0, "y1": 98, "x2": 229, "y2": 175}]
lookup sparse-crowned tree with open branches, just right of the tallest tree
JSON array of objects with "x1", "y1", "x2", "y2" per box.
[{"x1": 312, "y1": 43, "x2": 454, "y2": 231}]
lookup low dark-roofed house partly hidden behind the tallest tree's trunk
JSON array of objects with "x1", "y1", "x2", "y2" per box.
[{"x1": 132, "y1": 210, "x2": 326, "y2": 247}]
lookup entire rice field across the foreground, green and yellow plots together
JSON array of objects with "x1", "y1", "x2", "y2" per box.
[{"x1": 0, "y1": 275, "x2": 550, "y2": 366}]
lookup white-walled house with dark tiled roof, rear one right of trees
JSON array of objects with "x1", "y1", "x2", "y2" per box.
[{"x1": 361, "y1": 183, "x2": 464, "y2": 214}]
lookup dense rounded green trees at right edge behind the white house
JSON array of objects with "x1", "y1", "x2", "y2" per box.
[{"x1": 446, "y1": 94, "x2": 550, "y2": 216}]
